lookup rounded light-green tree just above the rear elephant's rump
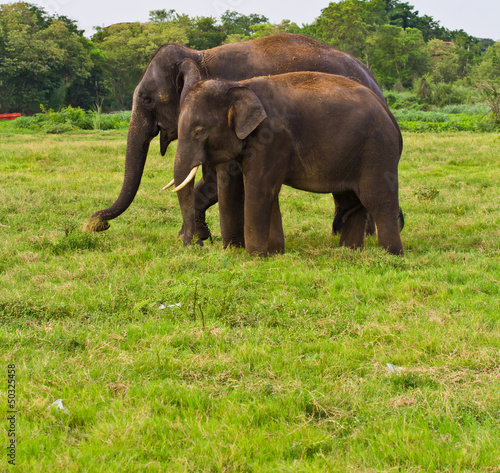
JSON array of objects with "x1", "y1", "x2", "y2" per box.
[{"x1": 367, "y1": 25, "x2": 429, "y2": 87}]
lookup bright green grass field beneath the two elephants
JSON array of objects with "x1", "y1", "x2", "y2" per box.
[{"x1": 0, "y1": 131, "x2": 500, "y2": 472}]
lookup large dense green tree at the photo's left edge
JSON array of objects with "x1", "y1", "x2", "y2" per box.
[{"x1": 0, "y1": 2, "x2": 92, "y2": 113}]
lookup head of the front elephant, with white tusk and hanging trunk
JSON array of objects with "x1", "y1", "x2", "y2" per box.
[{"x1": 172, "y1": 80, "x2": 267, "y2": 245}]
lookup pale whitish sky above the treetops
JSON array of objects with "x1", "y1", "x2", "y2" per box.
[{"x1": 0, "y1": 0, "x2": 500, "y2": 41}]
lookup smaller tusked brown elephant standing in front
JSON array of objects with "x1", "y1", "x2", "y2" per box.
[{"x1": 173, "y1": 72, "x2": 403, "y2": 256}]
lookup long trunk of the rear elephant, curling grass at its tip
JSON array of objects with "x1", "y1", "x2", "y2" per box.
[{"x1": 87, "y1": 110, "x2": 156, "y2": 231}]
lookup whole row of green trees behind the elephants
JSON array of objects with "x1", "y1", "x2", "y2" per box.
[{"x1": 0, "y1": 0, "x2": 500, "y2": 114}]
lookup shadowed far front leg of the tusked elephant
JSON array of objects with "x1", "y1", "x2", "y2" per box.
[{"x1": 217, "y1": 161, "x2": 245, "y2": 248}]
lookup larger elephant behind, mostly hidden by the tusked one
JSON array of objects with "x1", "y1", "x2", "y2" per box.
[{"x1": 87, "y1": 34, "x2": 385, "y2": 240}]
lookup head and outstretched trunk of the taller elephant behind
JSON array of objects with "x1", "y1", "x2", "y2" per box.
[{"x1": 87, "y1": 45, "x2": 201, "y2": 231}]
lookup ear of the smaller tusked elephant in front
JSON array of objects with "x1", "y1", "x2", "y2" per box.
[{"x1": 228, "y1": 87, "x2": 267, "y2": 140}]
